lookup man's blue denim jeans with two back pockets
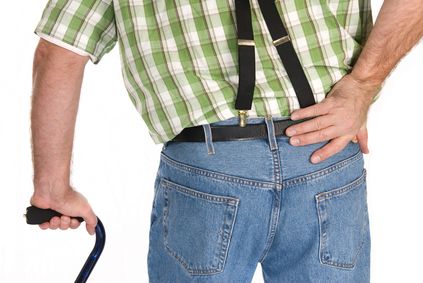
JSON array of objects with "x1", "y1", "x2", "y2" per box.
[{"x1": 147, "y1": 117, "x2": 370, "y2": 283}]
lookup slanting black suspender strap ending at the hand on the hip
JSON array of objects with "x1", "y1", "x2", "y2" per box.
[{"x1": 256, "y1": 0, "x2": 316, "y2": 108}]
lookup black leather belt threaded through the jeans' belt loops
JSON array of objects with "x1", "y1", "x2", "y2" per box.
[{"x1": 171, "y1": 118, "x2": 311, "y2": 142}]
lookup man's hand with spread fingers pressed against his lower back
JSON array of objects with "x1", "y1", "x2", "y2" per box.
[{"x1": 286, "y1": 74, "x2": 380, "y2": 163}]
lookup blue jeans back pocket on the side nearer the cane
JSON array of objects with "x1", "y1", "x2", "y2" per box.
[{"x1": 161, "y1": 178, "x2": 239, "y2": 275}]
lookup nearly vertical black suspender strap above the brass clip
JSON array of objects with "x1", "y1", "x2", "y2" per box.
[{"x1": 235, "y1": 0, "x2": 256, "y2": 112}]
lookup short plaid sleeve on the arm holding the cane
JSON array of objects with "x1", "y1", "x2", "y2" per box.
[{"x1": 34, "y1": 0, "x2": 117, "y2": 64}]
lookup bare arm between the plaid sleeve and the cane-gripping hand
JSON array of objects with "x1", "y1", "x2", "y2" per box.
[{"x1": 31, "y1": 38, "x2": 87, "y2": 201}]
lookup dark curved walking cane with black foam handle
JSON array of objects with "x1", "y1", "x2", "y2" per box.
[{"x1": 25, "y1": 206, "x2": 106, "y2": 283}]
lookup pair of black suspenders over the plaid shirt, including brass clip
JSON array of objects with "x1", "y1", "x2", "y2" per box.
[{"x1": 235, "y1": 0, "x2": 316, "y2": 127}]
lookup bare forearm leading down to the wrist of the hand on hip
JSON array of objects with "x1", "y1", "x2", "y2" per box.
[{"x1": 351, "y1": 0, "x2": 423, "y2": 85}]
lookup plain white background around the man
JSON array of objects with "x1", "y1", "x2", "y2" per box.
[{"x1": 0, "y1": 0, "x2": 423, "y2": 283}]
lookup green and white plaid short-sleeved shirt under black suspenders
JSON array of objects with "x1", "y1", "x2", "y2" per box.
[{"x1": 35, "y1": 0, "x2": 373, "y2": 144}]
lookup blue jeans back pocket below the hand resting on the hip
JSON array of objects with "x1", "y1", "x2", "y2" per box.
[{"x1": 315, "y1": 169, "x2": 369, "y2": 269}]
